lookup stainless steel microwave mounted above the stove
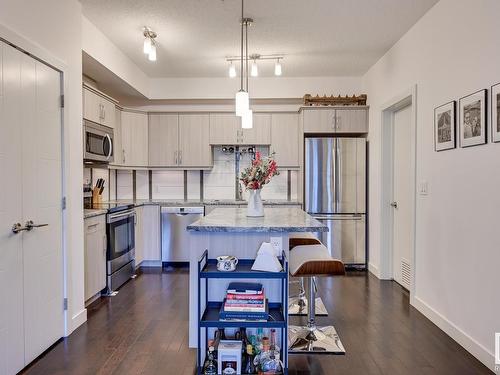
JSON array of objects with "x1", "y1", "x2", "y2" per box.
[{"x1": 83, "y1": 120, "x2": 113, "y2": 163}]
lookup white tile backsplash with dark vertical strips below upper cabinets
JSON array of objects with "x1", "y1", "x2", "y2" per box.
[{"x1": 84, "y1": 147, "x2": 298, "y2": 200}]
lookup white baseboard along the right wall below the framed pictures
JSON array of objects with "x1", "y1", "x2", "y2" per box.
[{"x1": 412, "y1": 297, "x2": 495, "y2": 371}]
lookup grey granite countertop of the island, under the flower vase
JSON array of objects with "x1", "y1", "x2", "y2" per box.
[{"x1": 187, "y1": 207, "x2": 328, "y2": 232}]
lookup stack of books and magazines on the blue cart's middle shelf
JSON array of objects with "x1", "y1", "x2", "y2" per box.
[{"x1": 219, "y1": 282, "x2": 269, "y2": 321}]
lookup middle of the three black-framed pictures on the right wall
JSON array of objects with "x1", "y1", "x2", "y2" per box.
[{"x1": 459, "y1": 90, "x2": 486, "y2": 147}]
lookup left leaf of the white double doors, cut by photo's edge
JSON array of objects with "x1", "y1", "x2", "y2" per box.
[{"x1": 0, "y1": 42, "x2": 24, "y2": 375}]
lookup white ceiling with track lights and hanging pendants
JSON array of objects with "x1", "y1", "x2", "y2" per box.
[{"x1": 81, "y1": 0, "x2": 438, "y2": 78}]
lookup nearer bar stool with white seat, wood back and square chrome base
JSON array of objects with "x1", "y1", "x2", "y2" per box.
[{"x1": 288, "y1": 244, "x2": 345, "y2": 354}]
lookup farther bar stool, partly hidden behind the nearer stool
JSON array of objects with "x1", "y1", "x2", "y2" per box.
[{"x1": 288, "y1": 232, "x2": 328, "y2": 316}]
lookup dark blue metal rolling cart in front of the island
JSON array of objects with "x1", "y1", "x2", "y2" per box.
[{"x1": 197, "y1": 250, "x2": 288, "y2": 374}]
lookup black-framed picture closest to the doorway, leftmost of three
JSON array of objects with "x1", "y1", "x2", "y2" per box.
[{"x1": 434, "y1": 101, "x2": 456, "y2": 151}]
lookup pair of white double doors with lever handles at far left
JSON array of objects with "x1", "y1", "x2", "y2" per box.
[{"x1": 0, "y1": 39, "x2": 64, "y2": 374}]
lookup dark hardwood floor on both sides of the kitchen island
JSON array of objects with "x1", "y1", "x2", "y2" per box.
[{"x1": 20, "y1": 270, "x2": 492, "y2": 375}]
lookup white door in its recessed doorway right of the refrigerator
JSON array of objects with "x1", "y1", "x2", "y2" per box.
[{"x1": 380, "y1": 86, "x2": 416, "y2": 300}]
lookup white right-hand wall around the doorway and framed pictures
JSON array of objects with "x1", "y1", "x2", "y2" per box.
[{"x1": 363, "y1": 0, "x2": 500, "y2": 368}]
